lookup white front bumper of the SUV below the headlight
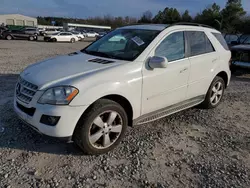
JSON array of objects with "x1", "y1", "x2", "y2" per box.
[{"x1": 14, "y1": 97, "x2": 87, "y2": 138}]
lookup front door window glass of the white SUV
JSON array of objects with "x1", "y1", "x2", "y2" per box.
[{"x1": 155, "y1": 32, "x2": 185, "y2": 62}]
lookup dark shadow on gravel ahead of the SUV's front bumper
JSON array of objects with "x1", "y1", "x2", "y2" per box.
[{"x1": 0, "y1": 74, "x2": 83, "y2": 155}]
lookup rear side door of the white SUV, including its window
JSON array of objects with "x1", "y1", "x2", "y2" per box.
[{"x1": 186, "y1": 30, "x2": 219, "y2": 99}]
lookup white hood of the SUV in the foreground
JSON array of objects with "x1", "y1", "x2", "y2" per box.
[{"x1": 21, "y1": 52, "x2": 122, "y2": 89}]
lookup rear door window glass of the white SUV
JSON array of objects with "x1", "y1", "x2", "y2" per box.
[{"x1": 187, "y1": 31, "x2": 215, "y2": 56}]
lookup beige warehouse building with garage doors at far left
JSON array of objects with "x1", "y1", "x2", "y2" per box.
[{"x1": 0, "y1": 14, "x2": 37, "y2": 27}]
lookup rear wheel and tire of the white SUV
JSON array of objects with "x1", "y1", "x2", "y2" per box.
[{"x1": 200, "y1": 76, "x2": 225, "y2": 109}]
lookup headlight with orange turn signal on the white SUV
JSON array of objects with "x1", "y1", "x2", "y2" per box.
[{"x1": 38, "y1": 86, "x2": 79, "y2": 105}]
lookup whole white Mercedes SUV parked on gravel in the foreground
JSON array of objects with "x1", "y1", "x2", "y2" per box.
[{"x1": 14, "y1": 24, "x2": 231, "y2": 154}]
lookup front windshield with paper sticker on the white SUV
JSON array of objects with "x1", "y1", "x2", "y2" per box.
[{"x1": 82, "y1": 29, "x2": 160, "y2": 61}]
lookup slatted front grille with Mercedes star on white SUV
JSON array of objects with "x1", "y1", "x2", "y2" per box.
[{"x1": 16, "y1": 77, "x2": 38, "y2": 104}]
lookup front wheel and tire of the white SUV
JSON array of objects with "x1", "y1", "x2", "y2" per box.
[{"x1": 73, "y1": 99, "x2": 128, "y2": 155}]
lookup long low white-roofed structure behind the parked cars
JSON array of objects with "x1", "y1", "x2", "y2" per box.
[{"x1": 63, "y1": 23, "x2": 111, "y2": 32}]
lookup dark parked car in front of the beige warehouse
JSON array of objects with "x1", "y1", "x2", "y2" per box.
[{"x1": 2, "y1": 30, "x2": 37, "y2": 41}]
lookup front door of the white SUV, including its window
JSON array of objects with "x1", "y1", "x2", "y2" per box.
[{"x1": 142, "y1": 31, "x2": 190, "y2": 115}]
